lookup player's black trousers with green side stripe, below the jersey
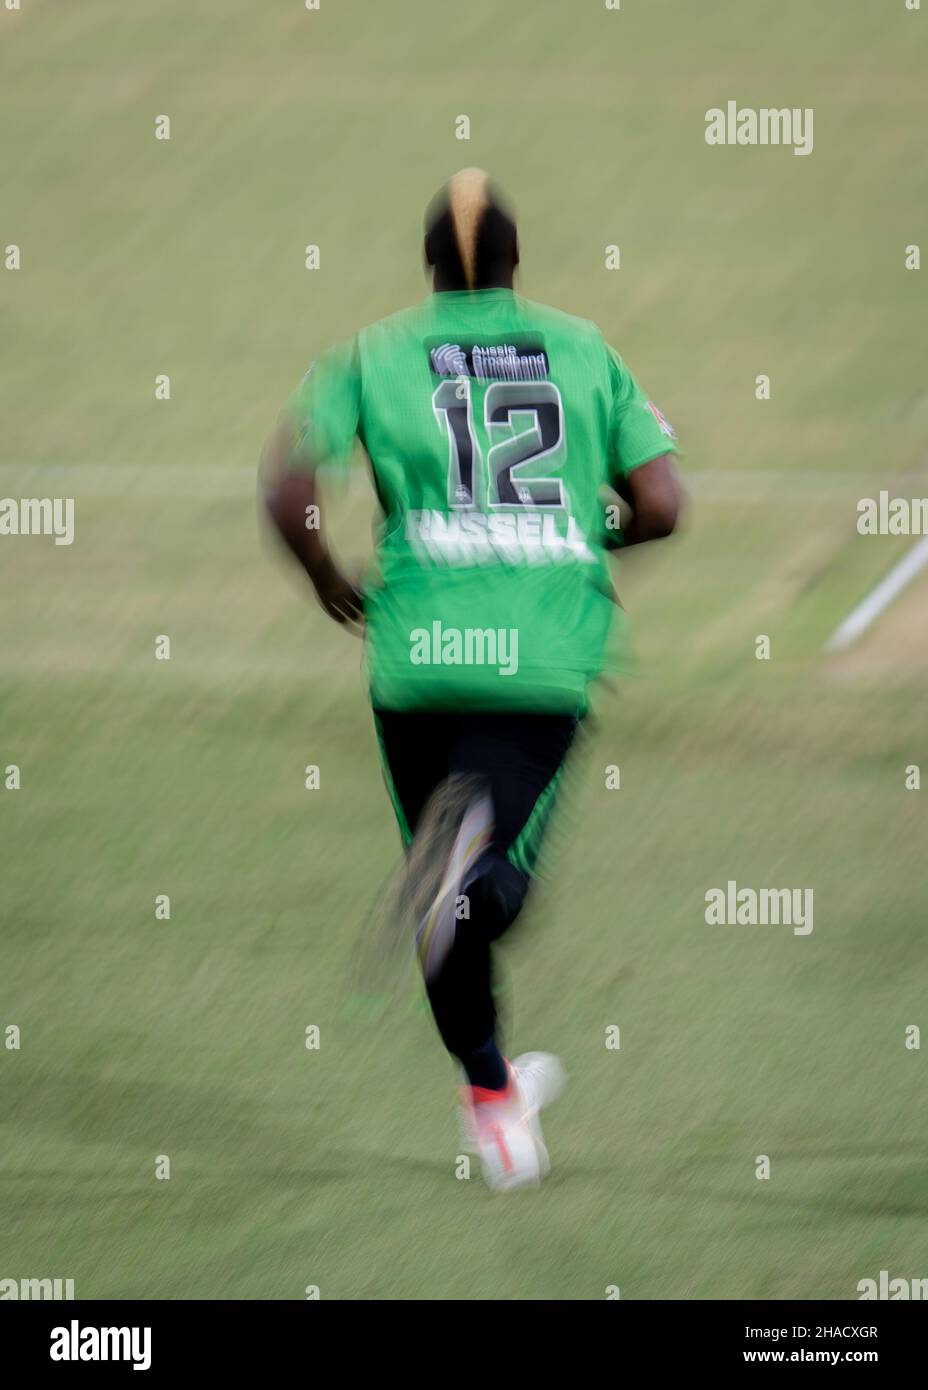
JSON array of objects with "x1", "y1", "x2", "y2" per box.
[{"x1": 374, "y1": 710, "x2": 578, "y2": 1065}]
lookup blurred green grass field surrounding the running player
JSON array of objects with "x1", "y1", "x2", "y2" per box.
[{"x1": 0, "y1": 0, "x2": 928, "y2": 1300}]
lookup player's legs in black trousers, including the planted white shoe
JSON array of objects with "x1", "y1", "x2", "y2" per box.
[{"x1": 376, "y1": 712, "x2": 575, "y2": 1188}]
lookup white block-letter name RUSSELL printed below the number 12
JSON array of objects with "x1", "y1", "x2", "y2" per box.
[{"x1": 406, "y1": 507, "x2": 596, "y2": 566}]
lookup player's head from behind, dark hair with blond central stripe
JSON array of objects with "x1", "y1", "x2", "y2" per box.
[{"x1": 425, "y1": 168, "x2": 518, "y2": 289}]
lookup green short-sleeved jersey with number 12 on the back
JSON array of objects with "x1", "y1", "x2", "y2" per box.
[{"x1": 290, "y1": 289, "x2": 674, "y2": 713}]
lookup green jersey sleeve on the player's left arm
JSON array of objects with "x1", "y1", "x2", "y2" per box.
[{"x1": 286, "y1": 338, "x2": 361, "y2": 470}]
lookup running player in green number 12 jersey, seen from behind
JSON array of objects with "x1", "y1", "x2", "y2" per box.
[{"x1": 265, "y1": 170, "x2": 681, "y2": 1190}]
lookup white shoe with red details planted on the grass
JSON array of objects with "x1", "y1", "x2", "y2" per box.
[{"x1": 461, "y1": 1052, "x2": 565, "y2": 1193}]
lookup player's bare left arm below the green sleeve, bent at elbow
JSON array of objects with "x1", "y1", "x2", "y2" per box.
[{"x1": 261, "y1": 416, "x2": 364, "y2": 623}]
